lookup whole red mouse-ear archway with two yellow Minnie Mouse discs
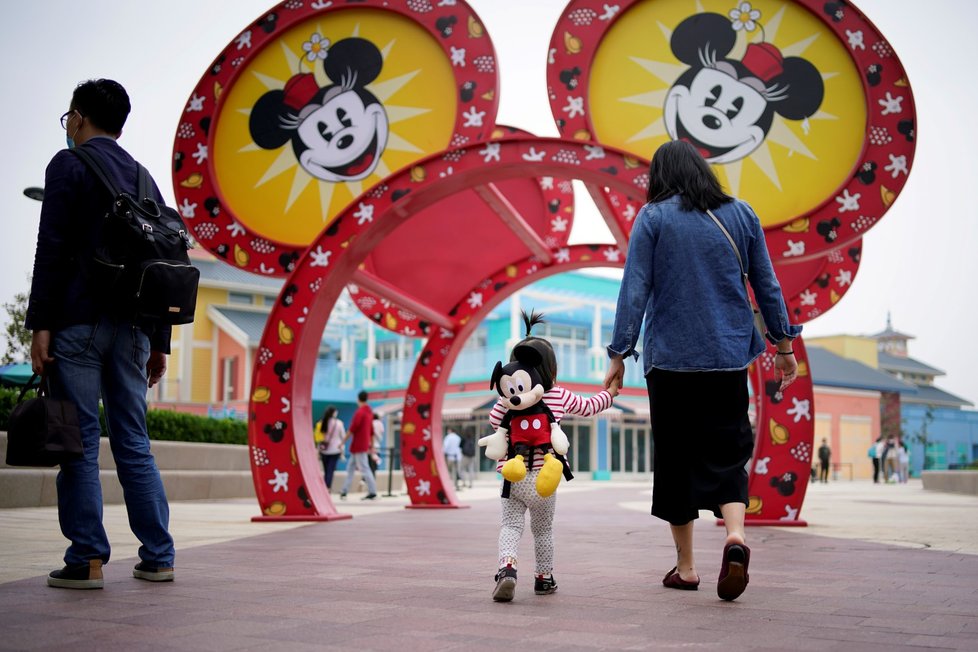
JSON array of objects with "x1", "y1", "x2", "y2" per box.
[{"x1": 174, "y1": 0, "x2": 915, "y2": 523}]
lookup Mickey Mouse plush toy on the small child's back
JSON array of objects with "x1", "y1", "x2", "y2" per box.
[{"x1": 479, "y1": 320, "x2": 573, "y2": 498}]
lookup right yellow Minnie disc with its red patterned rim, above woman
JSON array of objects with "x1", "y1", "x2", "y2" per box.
[{"x1": 547, "y1": 0, "x2": 916, "y2": 265}]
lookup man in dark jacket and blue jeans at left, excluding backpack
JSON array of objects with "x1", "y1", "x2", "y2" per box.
[{"x1": 24, "y1": 79, "x2": 174, "y2": 589}]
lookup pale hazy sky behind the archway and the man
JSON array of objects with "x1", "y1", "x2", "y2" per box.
[{"x1": 0, "y1": 0, "x2": 978, "y2": 403}]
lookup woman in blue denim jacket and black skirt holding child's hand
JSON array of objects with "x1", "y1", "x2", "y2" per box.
[{"x1": 605, "y1": 141, "x2": 801, "y2": 600}]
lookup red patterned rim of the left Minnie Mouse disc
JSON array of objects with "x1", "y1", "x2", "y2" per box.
[{"x1": 173, "y1": 0, "x2": 499, "y2": 276}]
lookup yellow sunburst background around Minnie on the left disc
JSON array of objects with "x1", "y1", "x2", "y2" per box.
[{"x1": 211, "y1": 9, "x2": 458, "y2": 245}]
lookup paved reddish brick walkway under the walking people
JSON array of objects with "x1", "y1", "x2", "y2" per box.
[{"x1": 0, "y1": 482, "x2": 978, "y2": 652}]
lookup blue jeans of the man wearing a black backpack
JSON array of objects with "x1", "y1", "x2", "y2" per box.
[{"x1": 51, "y1": 318, "x2": 174, "y2": 568}]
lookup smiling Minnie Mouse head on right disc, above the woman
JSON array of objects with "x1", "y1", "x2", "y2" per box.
[{"x1": 663, "y1": 13, "x2": 824, "y2": 163}]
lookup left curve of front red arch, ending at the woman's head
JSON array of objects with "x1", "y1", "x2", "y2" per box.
[{"x1": 249, "y1": 138, "x2": 647, "y2": 519}]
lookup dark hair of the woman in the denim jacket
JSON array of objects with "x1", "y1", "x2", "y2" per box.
[{"x1": 645, "y1": 140, "x2": 733, "y2": 211}]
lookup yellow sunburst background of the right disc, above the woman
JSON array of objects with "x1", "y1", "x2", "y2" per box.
[{"x1": 588, "y1": 0, "x2": 866, "y2": 226}]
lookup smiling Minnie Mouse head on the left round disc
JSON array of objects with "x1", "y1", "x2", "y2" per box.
[{"x1": 248, "y1": 38, "x2": 389, "y2": 182}]
